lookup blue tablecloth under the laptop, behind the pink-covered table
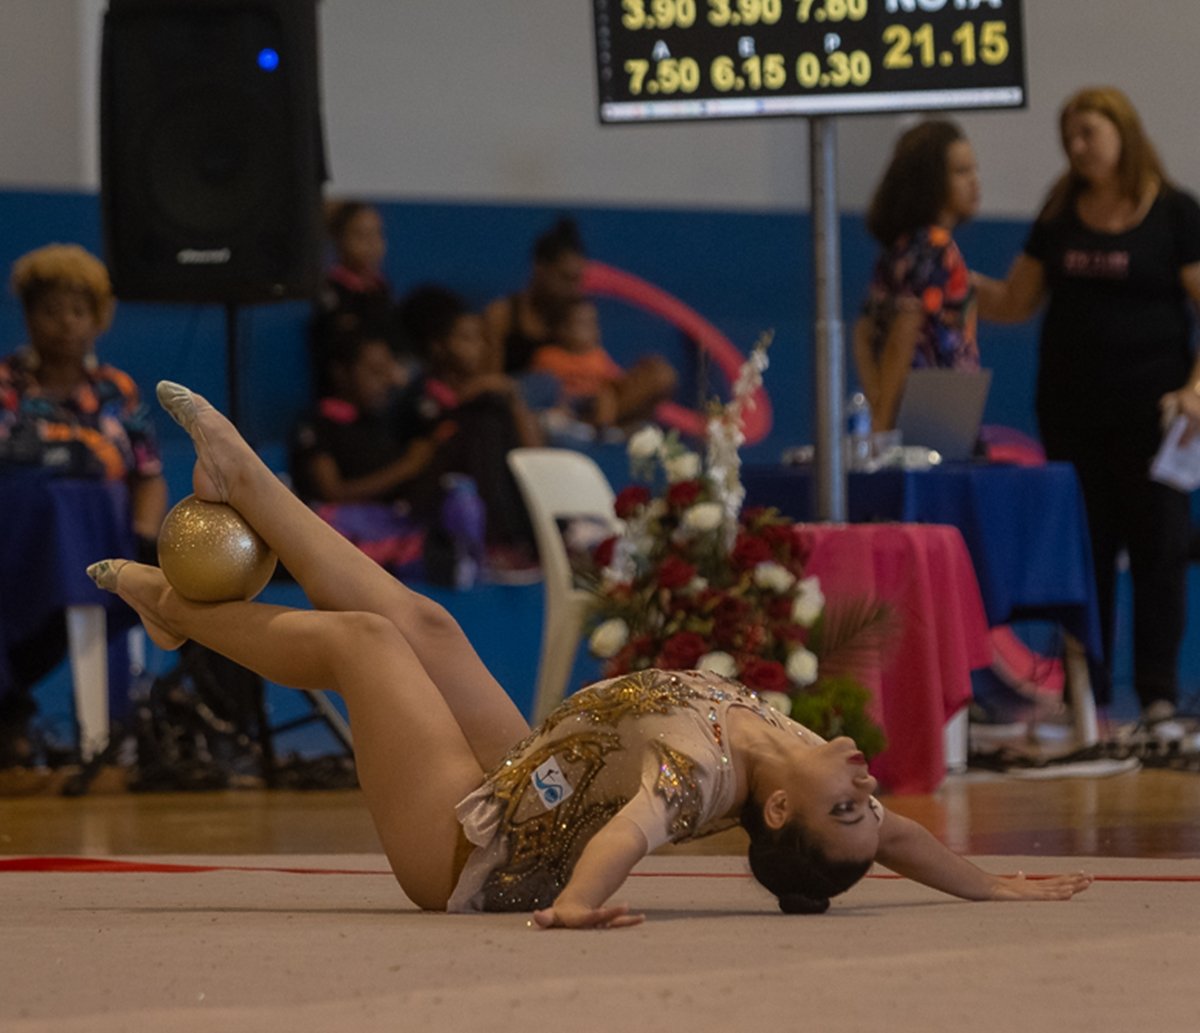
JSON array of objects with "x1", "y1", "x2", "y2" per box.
[{"x1": 742, "y1": 463, "x2": 1103, "y2": 659}]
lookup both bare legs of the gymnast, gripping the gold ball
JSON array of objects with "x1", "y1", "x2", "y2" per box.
[{"x1": 87, "y1": 385, "x2": 528, "y2": 908}]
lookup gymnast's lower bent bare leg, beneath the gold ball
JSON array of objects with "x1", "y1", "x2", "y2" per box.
[{"x1": 89, "y1": 560, "x2": 484, "y2": 909}]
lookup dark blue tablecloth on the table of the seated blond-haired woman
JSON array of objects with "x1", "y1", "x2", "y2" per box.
[{"x1": 0, "y1": 468, "x2": 136, "y2": 715}]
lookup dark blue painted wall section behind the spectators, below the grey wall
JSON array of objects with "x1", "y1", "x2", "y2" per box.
[{"x1": 0, "y1": 191, "x2": 1036, "y2": 461}]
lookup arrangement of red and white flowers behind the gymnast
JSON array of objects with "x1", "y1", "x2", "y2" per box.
[{"x1": 584, "y1": 335, "x2": 889, "y2": 756}]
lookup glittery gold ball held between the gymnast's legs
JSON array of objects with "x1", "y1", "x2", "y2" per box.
[{"x1": 158, "y1": 496, "x2": 275, "y2": 602}]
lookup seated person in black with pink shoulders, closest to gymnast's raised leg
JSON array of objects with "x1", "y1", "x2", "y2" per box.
[{"x1": 289, "y1": 332, "x2": 482, "y2": 588}]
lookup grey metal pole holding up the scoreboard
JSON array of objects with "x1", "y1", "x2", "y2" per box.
[{"x1": 809, "y1": 115, "x2": 846, "y2": 523}]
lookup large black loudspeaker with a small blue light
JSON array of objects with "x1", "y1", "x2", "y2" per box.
[{"x1": 100, "y1": 0, "x2": 325, "y2": 304}]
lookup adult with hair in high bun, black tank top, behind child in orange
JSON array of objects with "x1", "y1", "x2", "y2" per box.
[{"x1": 484, "y1": 217, "x2": 587, "y2": 409}]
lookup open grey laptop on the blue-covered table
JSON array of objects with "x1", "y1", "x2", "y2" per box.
[{"x1": 896, "y1": 370, "x2": 991, "y2": 462}]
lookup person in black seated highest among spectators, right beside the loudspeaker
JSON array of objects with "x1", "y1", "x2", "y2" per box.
[{"x1": 311, "y1": 200, "x2": 406, "y2": 397}]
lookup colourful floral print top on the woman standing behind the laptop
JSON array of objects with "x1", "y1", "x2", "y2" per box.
[{"x1": 864, "y1": 226, "x2": 979, "y2": 370}]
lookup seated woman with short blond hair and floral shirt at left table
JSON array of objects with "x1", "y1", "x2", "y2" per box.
[{"x1": 0, "y1": 244, "x2": 167, "y2": 767}]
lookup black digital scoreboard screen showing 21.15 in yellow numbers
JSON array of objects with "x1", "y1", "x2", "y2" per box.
[{"x1": 594, "y1": 0, "x2": 1026, "y2": 122}]
